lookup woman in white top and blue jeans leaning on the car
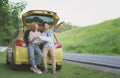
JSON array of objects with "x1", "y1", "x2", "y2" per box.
[{"x1": 28, "y1": 22, "x2": 43, "y2": 74}]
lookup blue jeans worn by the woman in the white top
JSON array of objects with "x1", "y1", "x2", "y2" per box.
[{"x1": 28, "y1": 43, "x2": 43, "y2": 67}]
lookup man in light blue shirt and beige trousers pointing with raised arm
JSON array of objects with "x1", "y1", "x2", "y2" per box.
[{"x1": 42, "y1": 22, "x2": 63, "y2": 74}]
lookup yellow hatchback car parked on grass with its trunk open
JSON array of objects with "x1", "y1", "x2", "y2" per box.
[{"x1": 6, "y1": 10, "x2": 62, "y2": 70}]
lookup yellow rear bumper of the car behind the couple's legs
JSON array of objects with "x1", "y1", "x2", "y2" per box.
[{"x1": 15, "y1": 47, "x2": 63, "y2": 65}]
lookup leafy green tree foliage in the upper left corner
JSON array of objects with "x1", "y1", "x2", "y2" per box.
[{"x1": 0, "y1": 0, "x2": 26, "y2": 45}]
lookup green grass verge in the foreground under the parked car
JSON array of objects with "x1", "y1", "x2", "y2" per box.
[{"x1": 0, "y1": 53, "x2": 120, "y2": 78}]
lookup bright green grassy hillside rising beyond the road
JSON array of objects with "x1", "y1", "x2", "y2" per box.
[{"x1": 57, "y1": 18, "x2": 120, "y2": 55}]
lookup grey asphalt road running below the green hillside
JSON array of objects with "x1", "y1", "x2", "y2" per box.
[{"x1": 63, "y1": 53, "x2": 120, "y2": 69}]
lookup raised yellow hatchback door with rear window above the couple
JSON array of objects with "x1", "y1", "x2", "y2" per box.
[{"x1": 22, "y1": 10, "x2": 59, "y2": 30}]
